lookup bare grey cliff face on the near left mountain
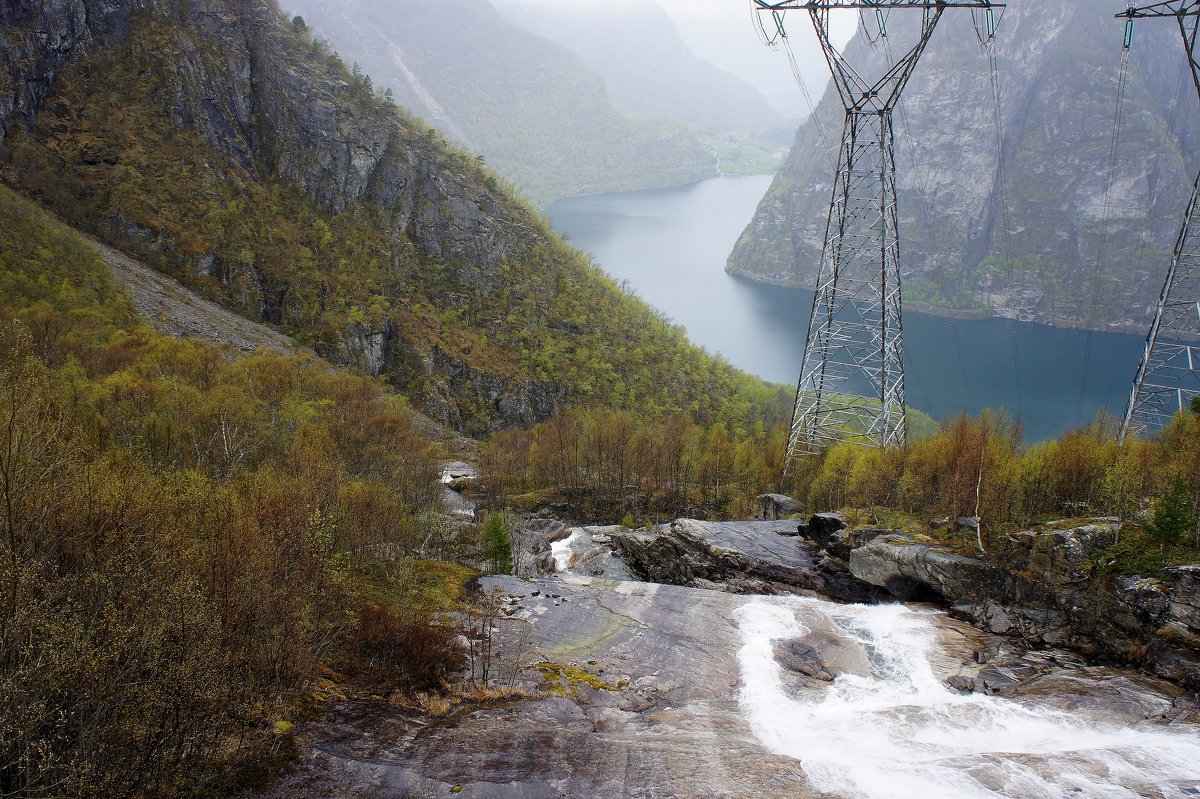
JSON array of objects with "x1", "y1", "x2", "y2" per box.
[{"x1": 0, "y1": 0, "x2": 535, "y2": 272}]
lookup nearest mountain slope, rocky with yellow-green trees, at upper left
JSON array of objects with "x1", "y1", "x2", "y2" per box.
[{"x1": 0, "y1": 0, "x2": 778, "y2": 432}]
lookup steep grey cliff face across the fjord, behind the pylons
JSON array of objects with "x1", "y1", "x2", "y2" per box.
[{"x1": 728, "y1": 0, "x2": 1200, "y2": 331}]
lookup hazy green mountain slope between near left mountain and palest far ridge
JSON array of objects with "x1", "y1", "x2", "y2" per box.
[{"x1": 276, "y1": 0, "x2": 716, "y2": 202}]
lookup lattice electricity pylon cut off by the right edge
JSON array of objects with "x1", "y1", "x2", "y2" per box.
[{"x1": 1117, "y1": 0, "x2": 1200, "y2": 440}]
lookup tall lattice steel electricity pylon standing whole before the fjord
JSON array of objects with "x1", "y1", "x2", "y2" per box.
[{"x1": 754, "y1": 0, "x2": 1006, "y2": 474}]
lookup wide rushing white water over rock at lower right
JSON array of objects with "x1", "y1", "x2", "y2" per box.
[{"x1": 737, "y1": 597, "x2": 1200, "y2": 799}]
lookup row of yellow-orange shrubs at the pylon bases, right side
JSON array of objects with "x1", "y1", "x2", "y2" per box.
[{"x1": 797, "y1": 411, "x2": 1200, "y2": 567}]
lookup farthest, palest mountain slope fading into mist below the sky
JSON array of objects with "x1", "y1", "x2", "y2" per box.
[{"x1": 494, "y1": 0, "x2": 785, "y2": 133}]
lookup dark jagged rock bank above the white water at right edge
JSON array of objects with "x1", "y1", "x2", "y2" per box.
[{"x1": 848, "y1": 519, "x2": 1200, "y2": 690}]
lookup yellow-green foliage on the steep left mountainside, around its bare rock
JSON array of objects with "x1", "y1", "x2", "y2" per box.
[{"x1": 6, "y1": 3, "x2": 786, "y2": 431}]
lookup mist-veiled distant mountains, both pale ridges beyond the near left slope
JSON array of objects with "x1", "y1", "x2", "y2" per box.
[{"x1": 284, "y1": 0, "x2": 790, "y2": 203}]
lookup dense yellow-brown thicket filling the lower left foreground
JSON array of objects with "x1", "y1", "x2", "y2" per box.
[{"x1": 0, "y1": 187, "x2": 461, "y2": 798}]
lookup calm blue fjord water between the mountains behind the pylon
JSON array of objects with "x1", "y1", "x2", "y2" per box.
[{"x1": 547, "y1": 176, "x2": 1142, "y2": 440}]
